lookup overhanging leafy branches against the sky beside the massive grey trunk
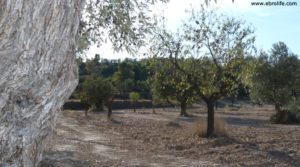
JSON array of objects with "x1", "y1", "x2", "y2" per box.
[{"x1": 79, "y1": 0, "x2": 168, "y2": 52}]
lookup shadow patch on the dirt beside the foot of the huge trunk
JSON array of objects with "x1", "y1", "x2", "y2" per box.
[{"x1": 38, "y1": 151, "x2": 91, "y2": 167}]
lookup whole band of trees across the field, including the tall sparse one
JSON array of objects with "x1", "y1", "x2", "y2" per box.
[{"x1": 77, "y1": 8, "x2": 300, "y2": 137}]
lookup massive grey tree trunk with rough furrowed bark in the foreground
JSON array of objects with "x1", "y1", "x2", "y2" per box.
[{"x1": 0, "y1": 0, "x2": 82, "y2": 167}]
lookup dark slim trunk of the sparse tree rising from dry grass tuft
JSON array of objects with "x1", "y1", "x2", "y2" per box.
[{"x1": 206, "y1": 100, "x2": 215, "y2": 137}]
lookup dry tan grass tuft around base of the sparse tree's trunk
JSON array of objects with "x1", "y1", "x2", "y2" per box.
[{"x1": 191, "y1": 117, "x2": 227, "y2": 137}]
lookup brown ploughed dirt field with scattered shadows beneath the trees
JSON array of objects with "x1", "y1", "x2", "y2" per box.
[{"x1": 40, "y1": 106, "x2": 300, "y2": 167}]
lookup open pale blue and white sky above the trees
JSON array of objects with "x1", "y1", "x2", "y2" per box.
[{"x1": 87, "y1": 0, "x2": 300, "y2": 59}]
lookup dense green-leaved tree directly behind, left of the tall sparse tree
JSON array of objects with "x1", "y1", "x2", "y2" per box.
[{"x1": 151, "y1": 59, "x2": 196, "y2": 116}]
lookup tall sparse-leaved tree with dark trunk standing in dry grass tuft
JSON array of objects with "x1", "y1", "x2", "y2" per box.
[{"x1": 152, "y1": 8, "x2": 254, "y2": 137}]
